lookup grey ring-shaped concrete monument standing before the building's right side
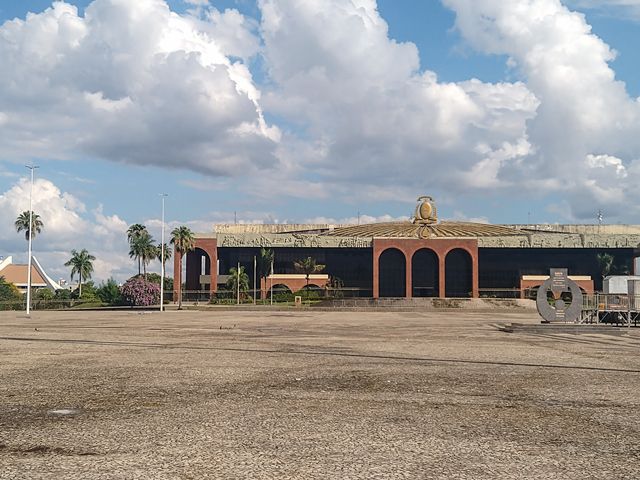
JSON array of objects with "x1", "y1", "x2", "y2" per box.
[{"x1": 536, "y1": 268, "x2": 582, "y2": 323}]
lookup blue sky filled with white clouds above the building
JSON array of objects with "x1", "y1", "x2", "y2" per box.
[{"x1": 0, "y1": 0, "x2": 640, "y2": 281}]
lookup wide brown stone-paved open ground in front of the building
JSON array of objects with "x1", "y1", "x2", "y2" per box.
[{"x1": 0, "y1": 311, "x2": 640, "y2": 480}]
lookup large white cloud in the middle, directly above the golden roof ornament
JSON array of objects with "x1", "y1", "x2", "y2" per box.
[{"x1": 259, "y1": 0, "x2": 539, "y2": 197}]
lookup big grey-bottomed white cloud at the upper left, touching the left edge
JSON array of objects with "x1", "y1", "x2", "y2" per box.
[{"x1": 0, "y1": 0, "x2": 279, "y2": 175}]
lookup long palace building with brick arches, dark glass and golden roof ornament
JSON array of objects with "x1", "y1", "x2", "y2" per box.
[{"x1": 174, "y1": 197, "x2": 640, "y2": 298}]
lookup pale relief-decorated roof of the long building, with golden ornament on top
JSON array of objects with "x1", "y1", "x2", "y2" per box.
[{"x1": 209, "y1": 196, "x2": 640, "y2": 248}]
